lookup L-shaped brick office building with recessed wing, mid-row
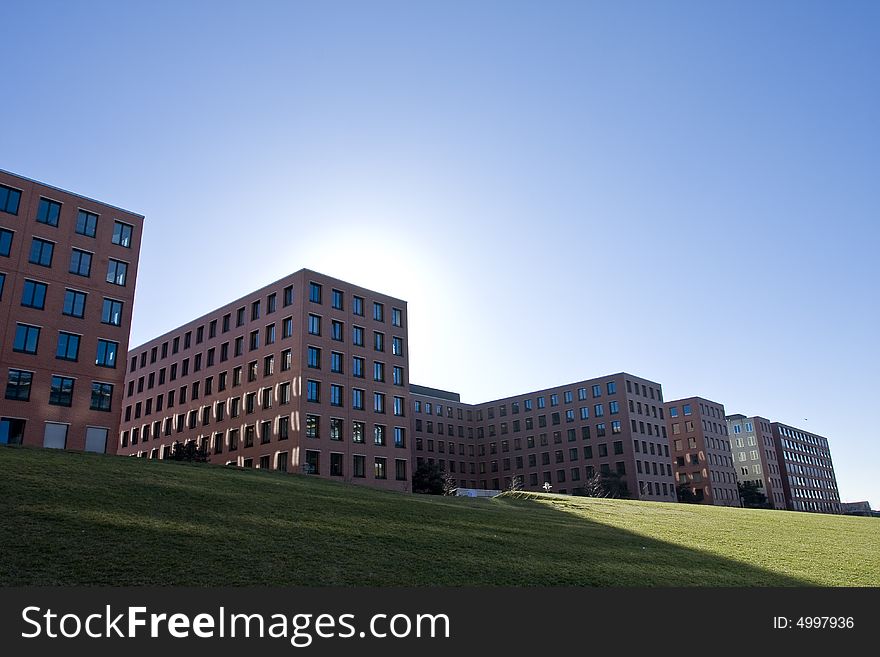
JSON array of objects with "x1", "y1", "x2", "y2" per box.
[{"x1": 412, "y1": 373, "x2": 675, "y2": 502}]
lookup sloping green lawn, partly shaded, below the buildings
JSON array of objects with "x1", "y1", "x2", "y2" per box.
[{"x1": 0, "y1": 447, "x2": 880, "y2": 586}]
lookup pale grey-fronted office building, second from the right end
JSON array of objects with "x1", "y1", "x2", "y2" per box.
[{"x1": 726, "y1": 414, "x2": 786, "y2": 509}]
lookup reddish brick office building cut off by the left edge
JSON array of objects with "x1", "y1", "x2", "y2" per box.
[{"x1": 0, "y1": 171, "x2": 144, "y2": 453}]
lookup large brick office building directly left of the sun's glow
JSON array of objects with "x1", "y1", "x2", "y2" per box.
[{"x1": 118, "y1": 269, "x2": 411, "y2": 491}]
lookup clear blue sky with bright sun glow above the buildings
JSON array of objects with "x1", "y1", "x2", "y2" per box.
[{"x1": 0, "y1": 0, "x2": 880, "y2": 508}]
